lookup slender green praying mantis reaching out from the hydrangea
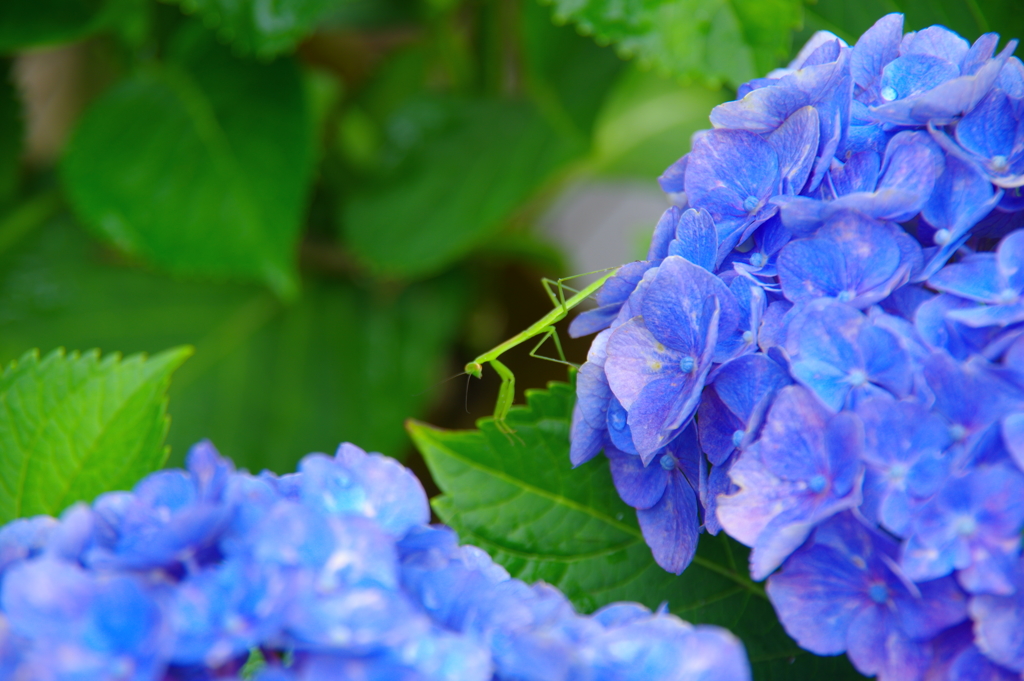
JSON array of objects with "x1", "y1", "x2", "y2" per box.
[{"x1": 466, "y1": 267, "x2": 618, "y2": 435}]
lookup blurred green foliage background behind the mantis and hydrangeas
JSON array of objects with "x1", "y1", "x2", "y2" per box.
[{"x1": 0, "y1": 0, "x2": 1024, "y2": 472}]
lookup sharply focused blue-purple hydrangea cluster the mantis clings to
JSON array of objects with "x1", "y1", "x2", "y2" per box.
[{"x1": 570, "y1": 14, "x2": 1024, "y2": 681}]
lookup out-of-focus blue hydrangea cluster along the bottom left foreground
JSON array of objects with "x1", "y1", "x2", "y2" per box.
[{"x1": 0, "y1": 442, "x2": 751, "y2": 681}]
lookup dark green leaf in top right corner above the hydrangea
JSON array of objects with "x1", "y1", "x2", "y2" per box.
[{"x1": 797, "y1": 0, "x2": 1024, "y2": 45}]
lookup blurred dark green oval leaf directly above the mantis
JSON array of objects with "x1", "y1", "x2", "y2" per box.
[{"x1": 341, "y1": 100, "x2": 586, "y2": 278}]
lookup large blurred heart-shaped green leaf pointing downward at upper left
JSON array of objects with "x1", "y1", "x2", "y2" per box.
[{"x1": 61, "y1": 25, "x2": 313, "y2": 297}]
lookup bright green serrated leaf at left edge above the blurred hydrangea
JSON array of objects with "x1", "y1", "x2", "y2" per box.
[{"x1": 0, "y1": 347, "x2": 191, "y2": 523}]
